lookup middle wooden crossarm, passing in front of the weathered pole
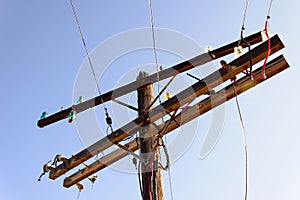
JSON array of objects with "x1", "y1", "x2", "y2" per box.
[{"x1": 49, "y1": 35, "x2": 284, "y2": 179}]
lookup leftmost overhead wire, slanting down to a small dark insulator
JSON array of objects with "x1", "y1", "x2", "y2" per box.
[{"x1": 70, "y1": 0, "x2": 113, "y2": 132}]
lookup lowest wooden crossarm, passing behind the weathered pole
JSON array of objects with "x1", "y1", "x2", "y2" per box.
[{"x1": 63, "y1": 56, "x2": 289, "y2": 188}]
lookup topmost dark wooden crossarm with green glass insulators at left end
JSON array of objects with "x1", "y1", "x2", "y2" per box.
[{"x1": 37, "y1": 32, "x2": 262, "y2": 128}]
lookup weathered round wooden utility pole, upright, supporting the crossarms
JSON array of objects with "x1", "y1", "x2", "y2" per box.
[{"x1": 137, "y1": 72, "x2": 164, "y2": 200}]
